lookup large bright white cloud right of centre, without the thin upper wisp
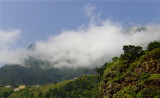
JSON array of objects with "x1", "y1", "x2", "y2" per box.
[{"x1": 32, "y1": 21, "x2": 160, "y2": 67}]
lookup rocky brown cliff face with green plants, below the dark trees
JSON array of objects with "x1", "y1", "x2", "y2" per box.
[{"x1": 100, "y1": 49, "x2": 160, "y2": 98}]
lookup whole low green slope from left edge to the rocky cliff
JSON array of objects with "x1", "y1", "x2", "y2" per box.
[{"x1": 0, "y1": 75, "x2": 100, "y2": 98}]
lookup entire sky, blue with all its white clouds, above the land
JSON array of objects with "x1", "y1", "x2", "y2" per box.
[{"x1": 0, "y1": 0, "x2": 160, "y2": 67}]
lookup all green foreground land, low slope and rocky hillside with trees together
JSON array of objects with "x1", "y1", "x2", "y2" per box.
[{"x1": 0, "y1": 42, "x2": 160, "y2": 98}]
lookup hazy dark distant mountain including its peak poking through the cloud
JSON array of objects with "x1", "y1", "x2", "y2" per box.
[{"x1": 0, "y1": 44, "x2": 95, "y2": 86}]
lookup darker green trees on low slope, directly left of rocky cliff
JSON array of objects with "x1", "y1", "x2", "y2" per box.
[{"x1": 44, "y1": 76, "x2": 99, "y2": 98}]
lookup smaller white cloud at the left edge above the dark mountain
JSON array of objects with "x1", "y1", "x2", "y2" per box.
[{"x1": 0, "y1": 29, "x2": 22, "y2": 64}]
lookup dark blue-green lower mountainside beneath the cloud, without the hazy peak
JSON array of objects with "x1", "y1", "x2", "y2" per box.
[{"x1": 0, "y1": 65, "x2": 94, "y2": 86}]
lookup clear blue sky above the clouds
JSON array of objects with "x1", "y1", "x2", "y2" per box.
[{"x1": 0, "y1": 0, "x2": 160, "y2": 47}]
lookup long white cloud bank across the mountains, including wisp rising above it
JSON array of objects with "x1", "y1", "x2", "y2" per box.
[{"x1": 0, "y1": 5, "x2": 160, "y2": 68}]
